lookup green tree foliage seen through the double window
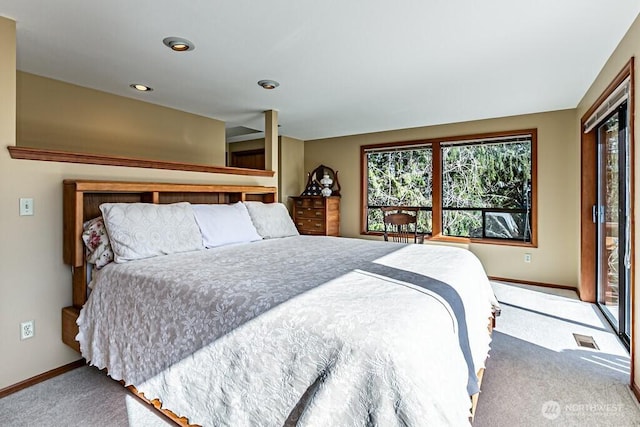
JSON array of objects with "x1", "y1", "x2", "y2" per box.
[{"x1": 367, "y1": 141, "x2": 531, "y2": 241}]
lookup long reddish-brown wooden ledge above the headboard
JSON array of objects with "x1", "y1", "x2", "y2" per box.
[{"x1": 7, "y1": 146, "x2": 274, "y2": 177}]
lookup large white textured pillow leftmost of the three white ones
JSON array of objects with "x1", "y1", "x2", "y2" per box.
[{"x1": 100, "y1": 202, "x2": 204, "y2": 262}]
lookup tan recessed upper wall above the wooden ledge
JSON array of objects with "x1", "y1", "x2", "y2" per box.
[{"x1": 17, "y1": 72, "x2": 225, "y2": 166}]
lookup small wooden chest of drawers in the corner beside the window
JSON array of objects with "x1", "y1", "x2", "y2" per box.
[{"x1": 292, "y1": 196, "x2": 340, "y2": 236}]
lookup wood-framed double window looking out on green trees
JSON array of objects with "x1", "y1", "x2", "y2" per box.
[{"x1": 362, "y1": 130, "x2": 536, "y2": 246}]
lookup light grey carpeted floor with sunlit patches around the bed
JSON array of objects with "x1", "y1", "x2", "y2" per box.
[{"x1": 0, "y1": 282, "x2": 640, "y2": 427}]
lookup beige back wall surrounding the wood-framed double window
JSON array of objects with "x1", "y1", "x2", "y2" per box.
[{"x1": 304, "y1": 110, "x2": 580, "y2": 287}]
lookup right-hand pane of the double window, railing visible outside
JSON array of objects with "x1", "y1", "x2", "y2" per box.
[{"x1": 441, "y1": 136, "x2": 531, "y2": 242}]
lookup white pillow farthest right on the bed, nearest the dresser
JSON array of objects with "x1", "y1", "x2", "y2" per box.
[{"x1": 244, "y1": 202, "x2": 300, "y2": 239}]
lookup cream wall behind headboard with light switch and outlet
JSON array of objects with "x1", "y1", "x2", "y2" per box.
[{"x1": 0, "y1": 18, "x2": 277, "y2": 389}]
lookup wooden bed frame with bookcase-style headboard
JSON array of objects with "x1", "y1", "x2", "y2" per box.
[{"x1": 62, "y1": 180, "x2": 495, "y2": 426}]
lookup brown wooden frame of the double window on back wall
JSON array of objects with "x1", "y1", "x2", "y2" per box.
[{"x1": 360, "y1": 128, "x2": 538, "y2": 248}]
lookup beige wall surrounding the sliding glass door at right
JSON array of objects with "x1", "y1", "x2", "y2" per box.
[{"x1": 574, "y1": 16, "x2": 640, "y2": 398}]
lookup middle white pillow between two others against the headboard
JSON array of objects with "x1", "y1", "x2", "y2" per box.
[{"x1": 191, "y1": 202, "x2": 262, "y2": 248}]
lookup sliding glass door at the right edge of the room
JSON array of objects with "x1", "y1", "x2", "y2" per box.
[{"x1": 594, "y1": 102, "x2": 631, "y2": 346}]
